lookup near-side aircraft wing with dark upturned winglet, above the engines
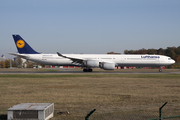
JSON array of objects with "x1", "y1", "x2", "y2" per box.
[{"x1": 57, "y1": 52, "x2": 86, "y2": 64}]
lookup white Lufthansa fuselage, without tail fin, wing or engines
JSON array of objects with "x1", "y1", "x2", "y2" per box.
[{"x1": 21, "y1": 54, "x2": 175, "y2": 67}]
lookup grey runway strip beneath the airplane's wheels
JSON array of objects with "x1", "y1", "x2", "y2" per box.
[{"x1": 0, "y1": 68, "x2": 180, "y2": 74}]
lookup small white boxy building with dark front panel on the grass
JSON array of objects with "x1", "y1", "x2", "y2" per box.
[{"x1": 7, "y1": 103, "x2": 54, "y2": 120}]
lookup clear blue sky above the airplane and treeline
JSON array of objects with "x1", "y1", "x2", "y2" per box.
[{"x1": 0, "y1": 0, "x2": 180, "y2": 57}]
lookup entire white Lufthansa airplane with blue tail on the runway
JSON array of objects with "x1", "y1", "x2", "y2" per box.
[{"x1": 9, "y1": 35, "x2": 175, "y2": 72}]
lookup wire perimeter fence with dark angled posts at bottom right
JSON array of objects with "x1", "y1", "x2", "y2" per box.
[{"x1": 82, "y1": 102, "x2": 180, "y2": 120}]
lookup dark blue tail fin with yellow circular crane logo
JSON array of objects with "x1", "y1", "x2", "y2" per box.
[{"x1": 12, "y1": 35, "x2": 40, "y2": 54}]
